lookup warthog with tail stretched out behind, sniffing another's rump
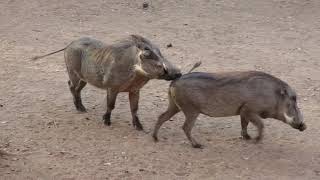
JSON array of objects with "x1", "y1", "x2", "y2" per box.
[{"x1": 33, "y1": 35, "x2": 181, "y2": 130}]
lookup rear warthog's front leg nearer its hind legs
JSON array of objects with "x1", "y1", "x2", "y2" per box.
[{"x1": 103, "y1": 89, "x2": 119, "y2": 126}]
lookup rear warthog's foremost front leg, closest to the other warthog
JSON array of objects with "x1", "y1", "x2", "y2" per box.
[{"x1": 129, "y1": 91, "x2": 143, "y2": 131}]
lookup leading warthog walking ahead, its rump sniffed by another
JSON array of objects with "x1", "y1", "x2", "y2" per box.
[{"x1": 153, "y1": 71, "x2": 306, "y2": 148}]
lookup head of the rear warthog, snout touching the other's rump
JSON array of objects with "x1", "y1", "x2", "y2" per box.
[{"x1": 131, "y1": 35, "x2": 181, "y2": 81}]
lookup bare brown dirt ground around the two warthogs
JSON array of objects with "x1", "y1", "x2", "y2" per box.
[{"x1": 0, "y1": 0, "x2": 320, "y2": 180}]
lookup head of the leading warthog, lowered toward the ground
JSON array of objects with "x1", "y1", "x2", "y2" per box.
[{"x1": 279, "y1": 86, "x2": 307, "y2": 131}]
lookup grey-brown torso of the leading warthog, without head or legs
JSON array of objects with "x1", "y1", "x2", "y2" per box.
[{"x1": 170, "y1": 71, "x2": 286, "y2": 117}]
